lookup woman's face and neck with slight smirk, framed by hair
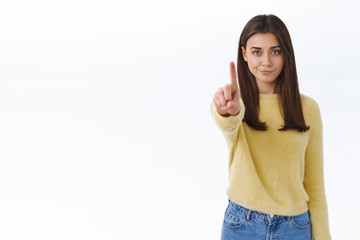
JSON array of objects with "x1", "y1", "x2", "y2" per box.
[{"x1": 242, "y1": 33, "x2": 284, "y2": 94}]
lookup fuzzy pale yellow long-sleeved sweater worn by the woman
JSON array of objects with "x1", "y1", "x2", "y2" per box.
[{"x1": 211, "y1": 94, "x2": 331, "y2": 240}]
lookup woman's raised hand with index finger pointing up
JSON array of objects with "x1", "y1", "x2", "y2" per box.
[{"x1": 213, "y1": 62, "x2": 240, "y2": 116}]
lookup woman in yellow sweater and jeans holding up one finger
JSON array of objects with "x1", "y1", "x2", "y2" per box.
[{"x1": 211, "y1": 15, "x2": 331, "y2": 240}]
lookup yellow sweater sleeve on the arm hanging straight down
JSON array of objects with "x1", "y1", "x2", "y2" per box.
[{"x1": 304, "y1": 101, "x2": 331, "y2": 240}]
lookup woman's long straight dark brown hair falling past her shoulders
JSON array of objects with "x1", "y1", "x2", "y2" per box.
[{"x1": 237, "y1": 14, "x2": 309, "y2": 132}]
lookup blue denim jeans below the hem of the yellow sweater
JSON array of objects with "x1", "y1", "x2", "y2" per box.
[{"x1": 221, "y1": 200, "x2": 313, "y2": 240}]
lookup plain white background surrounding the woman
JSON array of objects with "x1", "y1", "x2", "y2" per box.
[{"x1": 0, "y1": 0, "x2": 360, "y2": 240}]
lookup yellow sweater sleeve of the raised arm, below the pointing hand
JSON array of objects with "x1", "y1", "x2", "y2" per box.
[{"x1": 210, "y1": 97, "x2": 245, "y2": 147}]
